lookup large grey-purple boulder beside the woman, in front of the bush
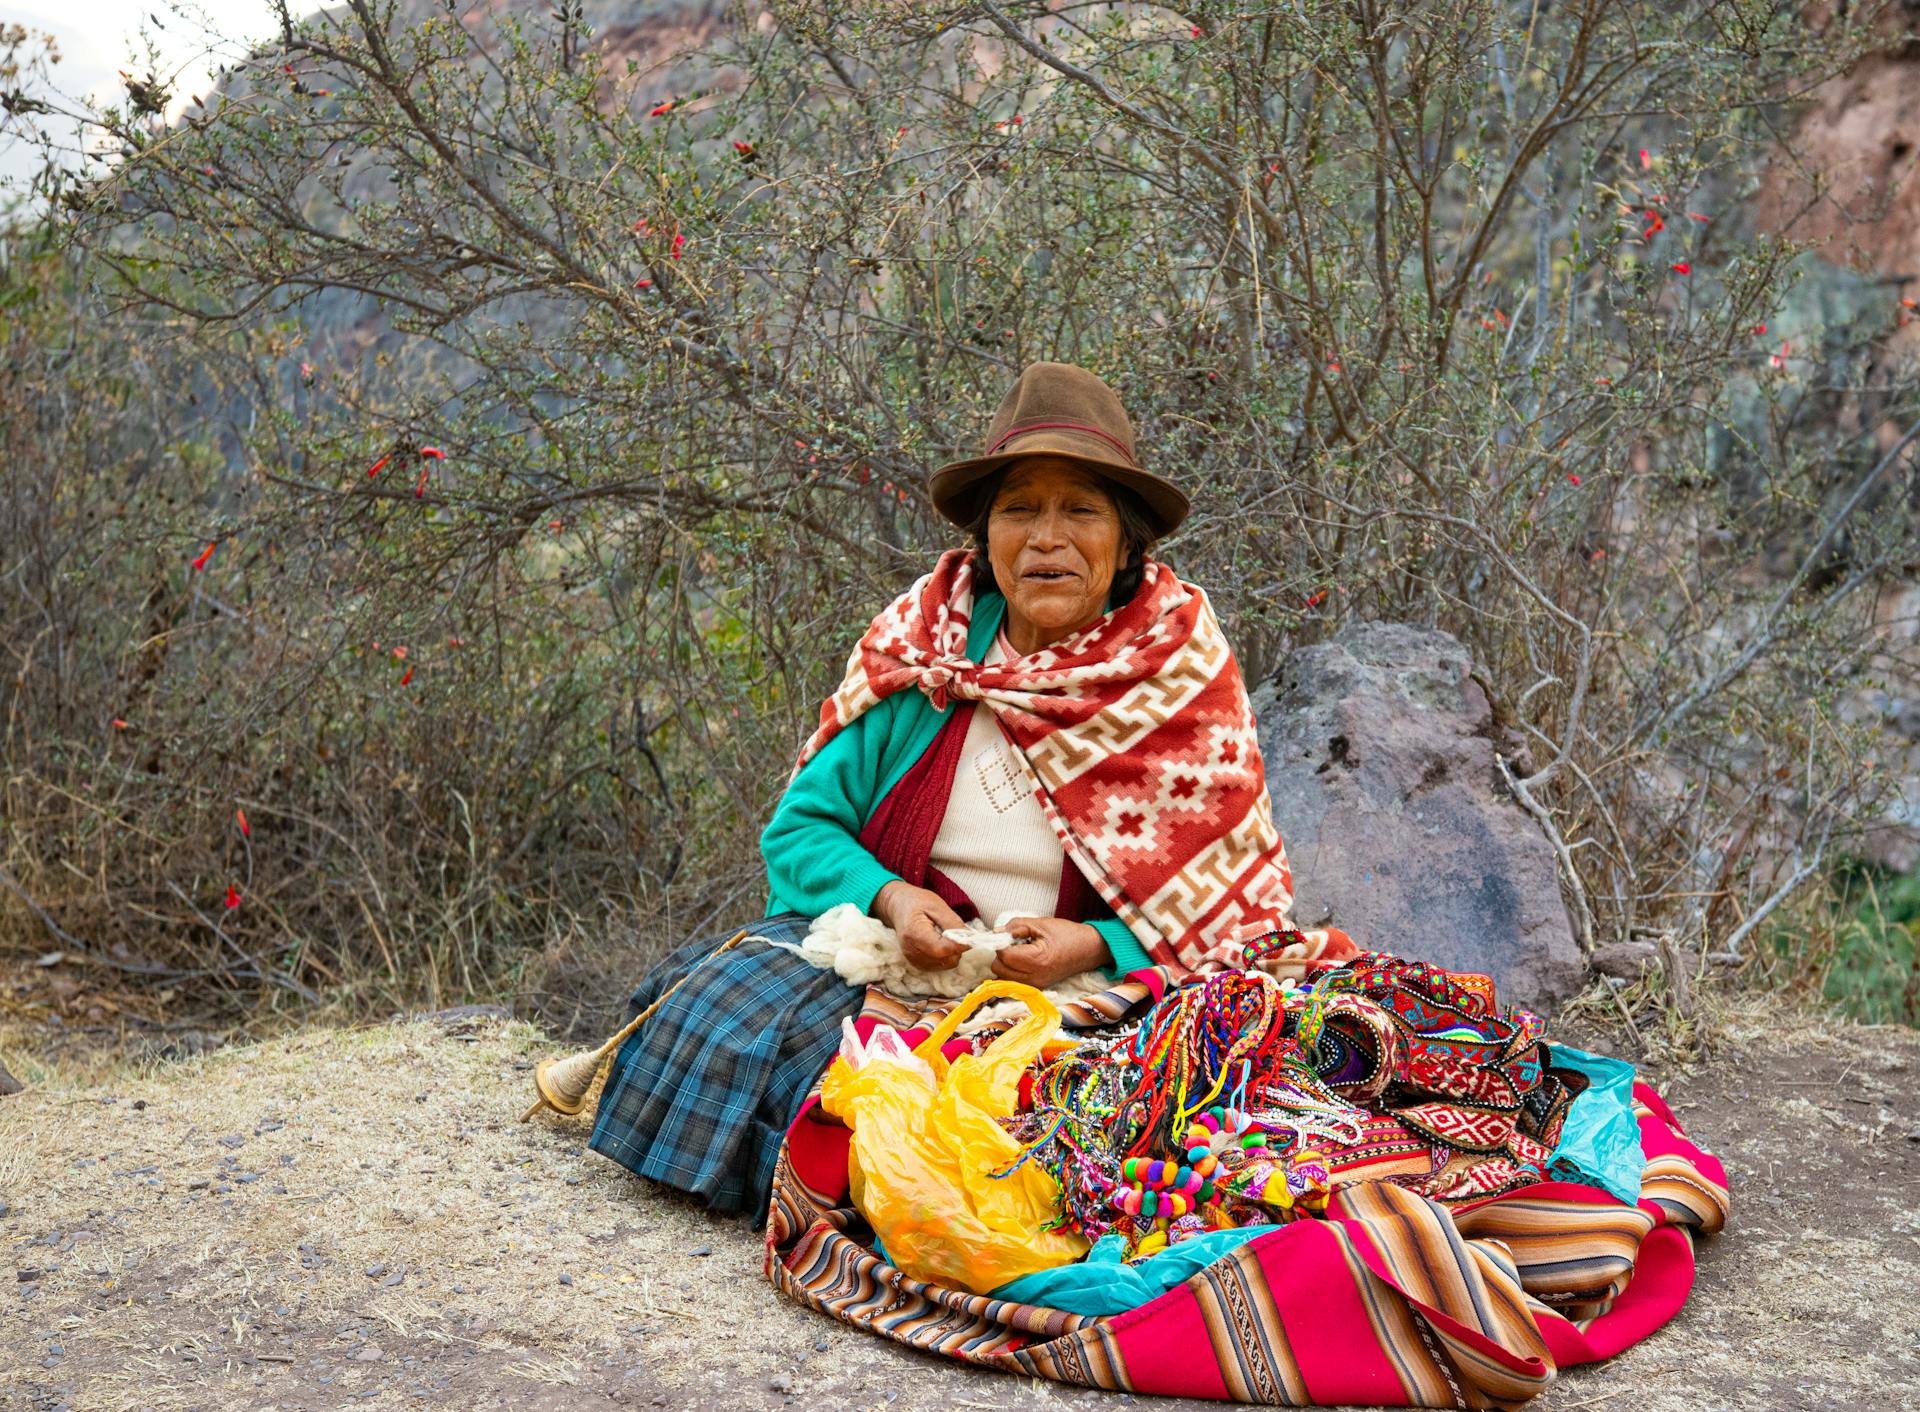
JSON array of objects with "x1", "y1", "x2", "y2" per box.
[{"x1": 1254, "y1": 622, "x2": 1586, "y2": 1010}]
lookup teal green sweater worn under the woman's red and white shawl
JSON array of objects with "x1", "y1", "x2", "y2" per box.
[{"x1": 760, "y1": 594, "x2": 1154, "y2": 976}]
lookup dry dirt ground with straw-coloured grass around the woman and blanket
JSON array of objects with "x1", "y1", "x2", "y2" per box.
[{"x1": 0, "y1": 1012, "x2": 1920, "y2": 1412}]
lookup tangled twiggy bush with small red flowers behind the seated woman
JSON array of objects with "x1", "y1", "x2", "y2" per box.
[{"x1": 6, "y1": 0, "x2": 1920, "y2": 1029}]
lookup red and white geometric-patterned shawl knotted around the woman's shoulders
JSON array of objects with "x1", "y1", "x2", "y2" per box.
[{"x1": 795, "y1": 549, "x2": 1311, "y2": 970}]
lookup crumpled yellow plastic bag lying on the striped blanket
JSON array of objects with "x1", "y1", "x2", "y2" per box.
[{"x1": 820, "y1": 980, "x2": 1087, "y2": 1295}]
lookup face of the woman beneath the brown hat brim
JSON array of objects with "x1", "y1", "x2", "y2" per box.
[{"x1": 987, "y1": 455, "x2": 1121, "y2": 655}]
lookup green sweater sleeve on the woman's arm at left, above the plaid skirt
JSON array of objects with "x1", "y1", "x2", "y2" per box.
[{"x1": 760, "y1": 701, "x2": 899, "y2": 916}]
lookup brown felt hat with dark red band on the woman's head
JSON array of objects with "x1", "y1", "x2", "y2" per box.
[{"x1": 929, "y1": 363, "x2": 1187, "y2": 534}]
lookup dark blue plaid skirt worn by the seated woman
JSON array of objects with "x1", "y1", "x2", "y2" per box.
[{"x1": 588, "y1": 913, "x2": 866, "y2": 1224}]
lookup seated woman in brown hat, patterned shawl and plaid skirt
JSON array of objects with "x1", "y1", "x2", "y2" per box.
[{"x1": 591, "y1": 363, "x2": 1344, "y2": 1218}]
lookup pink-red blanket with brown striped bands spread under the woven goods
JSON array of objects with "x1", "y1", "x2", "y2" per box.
[{"x1": 766, "y1": 972, "x2": 1728, "y2": 1408}]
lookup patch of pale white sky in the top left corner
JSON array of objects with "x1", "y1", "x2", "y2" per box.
[{"x1": 0, "y1": 0, "x2": 291, "y2": 198}]
